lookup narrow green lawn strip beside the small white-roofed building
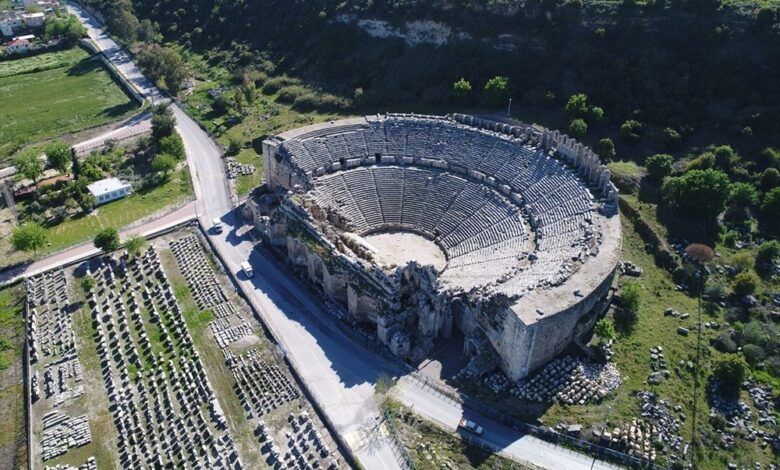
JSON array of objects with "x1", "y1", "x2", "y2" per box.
[{"x1": 39, "y1": 169, "x2": 192, "y2": 252}]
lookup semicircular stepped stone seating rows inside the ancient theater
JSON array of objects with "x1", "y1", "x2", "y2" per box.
[{"x1": 280, "y1": 118, "x2": 596, "y2": 295}]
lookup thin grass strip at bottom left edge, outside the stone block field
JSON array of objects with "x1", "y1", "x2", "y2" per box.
[{"x1": 0, "y1": 283, "x2": 27, "y2": 468}]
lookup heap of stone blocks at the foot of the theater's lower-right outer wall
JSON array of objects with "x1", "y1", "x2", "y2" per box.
[{"x1": 516, "y1": 356, "x2": 620, "y2": 405}]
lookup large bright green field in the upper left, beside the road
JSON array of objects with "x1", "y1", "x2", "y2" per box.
[{"x1": 0, "y1": 48, "x2": 138, "y2": 159}]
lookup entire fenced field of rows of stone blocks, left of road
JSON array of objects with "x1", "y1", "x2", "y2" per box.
[{"x1": 27, "y1": 232, "x2": 345, "y2": 470}]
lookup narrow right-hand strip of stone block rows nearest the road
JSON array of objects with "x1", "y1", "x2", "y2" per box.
[{"x1": 170, "y1": 235, "x2": 345, "y2": 469}]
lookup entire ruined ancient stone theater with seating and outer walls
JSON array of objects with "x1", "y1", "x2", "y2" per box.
[{"x1": 248, "y1": 114, "x2": 620, "y2": 379}]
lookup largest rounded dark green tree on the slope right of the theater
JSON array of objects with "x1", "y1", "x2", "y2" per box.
[{"x1": 661, "y1": 169, "x2": 731, "y2": 219}]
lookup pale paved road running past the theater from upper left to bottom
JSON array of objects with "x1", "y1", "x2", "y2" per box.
[{"x1": 53, "y1": 5, "x2": 620, "y2": 470}]
